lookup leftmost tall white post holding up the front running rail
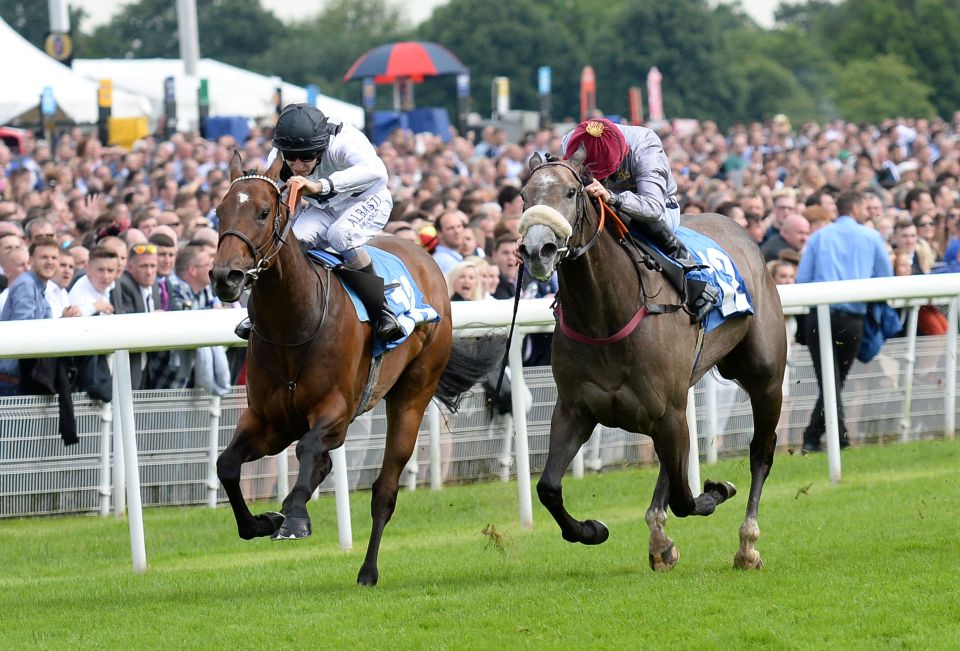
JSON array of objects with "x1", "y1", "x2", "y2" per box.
[{"x1": 113, "y1": 350, "x2": 147, "y2": 574}]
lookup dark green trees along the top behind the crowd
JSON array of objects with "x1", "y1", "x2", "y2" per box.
[{"x1": 7, "y1": 0, "x2": 960, "y2": 125}]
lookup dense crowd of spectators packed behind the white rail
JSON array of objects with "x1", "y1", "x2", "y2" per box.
[{"x1": 0, "y1": 112, "x2": 960, "y2": 393}]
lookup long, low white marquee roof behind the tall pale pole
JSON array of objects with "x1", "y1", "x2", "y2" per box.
[{"x1": 73, "y1": 59, "x2": 364, "y2": 129}]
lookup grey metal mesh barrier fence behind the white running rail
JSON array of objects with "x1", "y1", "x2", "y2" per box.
[{"x1": 0, "y1": 337, "x2": 956, "y2": 517}]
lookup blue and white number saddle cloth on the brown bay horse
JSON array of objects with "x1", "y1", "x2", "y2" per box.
[{"x1": 307, "y1": 245, "x2": 440, "y2": 355}]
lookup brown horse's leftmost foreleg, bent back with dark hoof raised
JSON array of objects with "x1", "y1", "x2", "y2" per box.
[{"x1": 217, "y1": 410, "x2": 283, "y2": 540}]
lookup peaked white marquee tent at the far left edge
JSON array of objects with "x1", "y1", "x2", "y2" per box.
[{"x1": 0, "y1": 20, "x2": 151, "y2": 124}]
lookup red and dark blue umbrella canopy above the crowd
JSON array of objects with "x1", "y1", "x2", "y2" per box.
[{"x1": 343, "y1": 41, "x2": 467, "y2": 84}]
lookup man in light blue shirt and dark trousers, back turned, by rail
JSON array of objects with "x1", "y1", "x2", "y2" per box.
[{"x1": 797, "y1": 192, "x2": 893, "y2": 452}]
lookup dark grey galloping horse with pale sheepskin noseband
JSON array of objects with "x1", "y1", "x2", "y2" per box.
[{"x1": 520, "y1": 147, "x2": 786, "y2": 571}]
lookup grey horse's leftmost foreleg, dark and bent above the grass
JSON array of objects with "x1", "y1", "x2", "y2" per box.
[{"x1": 537, "y1": 400, "x2": 610, "y2": 545}]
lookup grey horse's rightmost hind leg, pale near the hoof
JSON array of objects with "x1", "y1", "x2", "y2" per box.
[{"x1": 733, "y1": 382, "x2": 783, "y2": 570}]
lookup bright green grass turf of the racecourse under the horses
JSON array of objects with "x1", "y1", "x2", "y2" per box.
[{"x1": 0, "y1": 442, "x2": 960, "y2": 650}]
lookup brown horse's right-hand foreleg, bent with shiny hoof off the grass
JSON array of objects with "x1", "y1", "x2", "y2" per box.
[{"x1": 273, "y1": 425, "x2": 345, "y2": 540}]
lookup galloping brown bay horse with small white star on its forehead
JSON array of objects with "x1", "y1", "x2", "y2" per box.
[{"x1": 210, "y1": 154, "x2": 484, "y2": 585}]
